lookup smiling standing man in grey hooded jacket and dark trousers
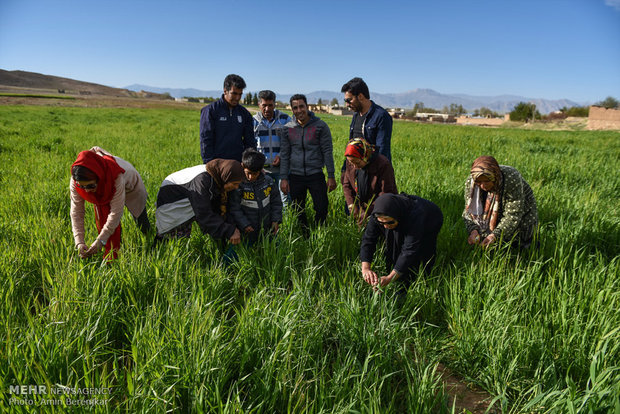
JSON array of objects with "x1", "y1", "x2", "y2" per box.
[{"x1": 280, "y1": 94, "x2": 336, "y2": 229}]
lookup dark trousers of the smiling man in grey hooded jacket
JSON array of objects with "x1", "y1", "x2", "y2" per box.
[{"x1": 288, "y1": 172, "x2": 328, "y2": 229}]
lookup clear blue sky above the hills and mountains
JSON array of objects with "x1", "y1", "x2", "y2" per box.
[{"x1": 0, "y1": 0, "x2": 620, "y2": 103}]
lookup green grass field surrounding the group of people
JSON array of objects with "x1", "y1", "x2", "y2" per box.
[{"x1": 0, "y1": 106, "x2": 620, "y2": 413}]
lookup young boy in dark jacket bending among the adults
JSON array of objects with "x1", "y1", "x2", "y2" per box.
[{"x1": 229, "y1": 148, "x2": 282, "y2": 244}]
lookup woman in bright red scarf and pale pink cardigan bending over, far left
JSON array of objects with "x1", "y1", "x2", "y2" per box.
[{"x1": 69, "y1": 147, "x2": 150, "y2": 258}]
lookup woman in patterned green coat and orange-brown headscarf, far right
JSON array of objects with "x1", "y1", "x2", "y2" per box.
[{"x1": 463, "y1": 156, "x2": 538, "y2": 248}]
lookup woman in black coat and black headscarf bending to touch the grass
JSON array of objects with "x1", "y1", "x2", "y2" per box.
[{"x1": 360, "y1": 193, "x2": 443, "y2": 288}]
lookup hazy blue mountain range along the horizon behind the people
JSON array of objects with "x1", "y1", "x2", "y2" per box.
[{"x1": 125, "y1": 84, "x2": 584, "y2": 114}]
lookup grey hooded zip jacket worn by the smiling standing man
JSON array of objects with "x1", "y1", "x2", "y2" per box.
[{"x1": 280, "y1": 112, "x2": 334, "y2": 179}]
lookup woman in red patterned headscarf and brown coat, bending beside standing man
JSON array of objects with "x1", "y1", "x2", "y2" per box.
[{"x1": 342, "y1": 138, "x2": 398, "y2": 226}]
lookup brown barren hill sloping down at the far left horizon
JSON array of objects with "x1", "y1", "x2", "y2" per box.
[{"x1": 0, "y1": 69, "x2": 171, "y2": 99}]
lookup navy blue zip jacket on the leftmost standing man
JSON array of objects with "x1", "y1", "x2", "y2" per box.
[{"x1": 200, "y1": 95, "x2": 256, "y2": 163}]
